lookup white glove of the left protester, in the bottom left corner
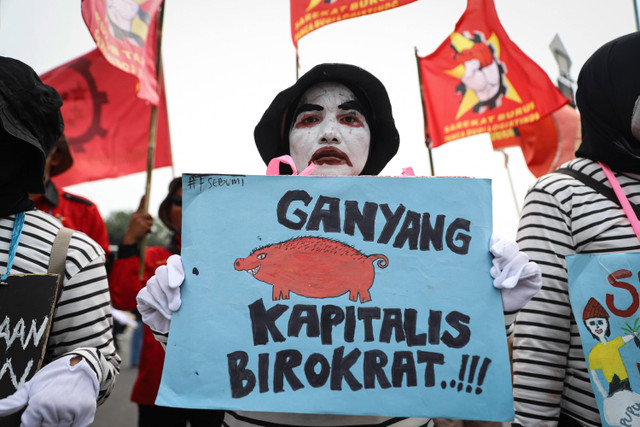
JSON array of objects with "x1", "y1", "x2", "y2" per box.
[{"x1": 0, "y1": 354, "x2": 99, "y2": 427}]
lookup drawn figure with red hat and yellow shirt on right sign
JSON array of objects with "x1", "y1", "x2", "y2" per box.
[{"x1": 582, "y1": 298, "x2": 640, "y2": 426}]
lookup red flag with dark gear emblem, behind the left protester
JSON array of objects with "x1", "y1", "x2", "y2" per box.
[{"x1": 40, "y1": 49, "x2": 171, "y2": 187}]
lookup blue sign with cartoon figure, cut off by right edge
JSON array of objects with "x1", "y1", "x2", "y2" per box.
[{"x1": 567, "y1": 254, "x2": 640, "y2": 426}]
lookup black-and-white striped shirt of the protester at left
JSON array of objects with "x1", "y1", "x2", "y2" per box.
[{"x1": 0, "y1": 210, "x2": 120, "y2": 404}]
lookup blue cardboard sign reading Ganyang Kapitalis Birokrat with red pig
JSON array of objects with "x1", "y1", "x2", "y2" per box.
[{"x1": 156, "y1": 175, "x2": 513, "y2": 421}]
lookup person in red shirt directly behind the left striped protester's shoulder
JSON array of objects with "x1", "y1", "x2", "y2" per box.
[{"x1": 29, "y1": 134, "x2": 110, "y2": 254}]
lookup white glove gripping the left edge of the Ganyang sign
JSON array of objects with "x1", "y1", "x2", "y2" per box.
[{"x1": 136, "y1": 255, "x2": 184, "y2": 334}]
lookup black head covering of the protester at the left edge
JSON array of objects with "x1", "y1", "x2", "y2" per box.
[{"x1": 0, "y1": 57, "x2": 64, "y2": 216}]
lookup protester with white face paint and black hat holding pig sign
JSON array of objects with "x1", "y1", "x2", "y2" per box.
[{"x1": 138, "y1": 64, "x2": 541, "y2": 426}]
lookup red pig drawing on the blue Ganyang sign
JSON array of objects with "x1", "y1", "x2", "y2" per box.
[{"x1": 234, "y1": 237, "x2": 389, "y2": 302}]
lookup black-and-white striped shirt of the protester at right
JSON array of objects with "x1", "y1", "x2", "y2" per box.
[{"x1": 513, "y1": 158, "x2": 640, "y2": 426}]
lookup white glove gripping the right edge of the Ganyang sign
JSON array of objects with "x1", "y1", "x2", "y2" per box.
[{"x1": 489, "y1": 236, "x2": 542, "y2": 312}]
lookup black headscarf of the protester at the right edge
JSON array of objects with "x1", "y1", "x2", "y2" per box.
[{"x1": 576, "y1": 32, "x2": 640, "y2": 173}]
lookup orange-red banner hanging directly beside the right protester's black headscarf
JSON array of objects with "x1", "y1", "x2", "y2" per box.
[{"x1": 491, "y1": 105, "x2": 582, "y2": 177}]
